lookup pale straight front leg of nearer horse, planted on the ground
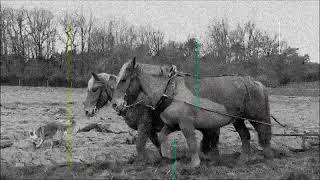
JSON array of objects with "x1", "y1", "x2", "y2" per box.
[{"x1": 179, "y1": 120, "x2": 201, "y2": 168}]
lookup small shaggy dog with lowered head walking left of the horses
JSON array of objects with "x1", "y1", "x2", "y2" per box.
[{"x1": 29, "y1": 121, "x2": 75, "y2": 149}]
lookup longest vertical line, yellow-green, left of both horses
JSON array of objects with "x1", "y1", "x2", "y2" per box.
[{"x1": 67, "y1": 25, "x2": 71, "y2": 176}]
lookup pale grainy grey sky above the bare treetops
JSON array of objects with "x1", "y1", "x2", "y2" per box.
[{"x1": 1, "y1": 0, "x2": 319, "y2": 63}]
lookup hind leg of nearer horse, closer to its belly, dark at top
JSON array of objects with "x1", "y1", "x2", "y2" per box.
[{"x1": 233, "y1": 119, "x2": 250, "y2": 163}]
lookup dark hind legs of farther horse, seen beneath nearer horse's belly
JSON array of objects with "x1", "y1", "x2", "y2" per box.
[{"x1": 200, "y1": 128, "x2": 220, "y2": 156}]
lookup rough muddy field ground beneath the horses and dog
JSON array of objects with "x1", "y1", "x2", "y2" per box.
[{"x1": 1, "y1": 86, "x2": 320, "y2": 179}]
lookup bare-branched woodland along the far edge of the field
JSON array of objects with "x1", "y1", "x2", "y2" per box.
[{"x1": 0, "y1": 7, "x2": 319, "y2": 87}]
